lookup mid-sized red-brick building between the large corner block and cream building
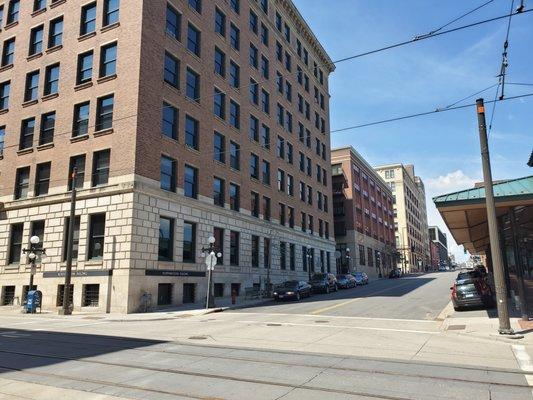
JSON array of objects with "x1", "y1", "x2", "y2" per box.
[{"x1": 331, "y1": 147, "x2": 396, "y2": 277}]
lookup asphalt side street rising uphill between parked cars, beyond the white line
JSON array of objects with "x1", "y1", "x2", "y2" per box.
[{"x1": 240, "y1": 272, "x2": 457, "y2": 320}]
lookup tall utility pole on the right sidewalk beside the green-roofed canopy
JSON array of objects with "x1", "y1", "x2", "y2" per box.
[{"x1": 476, "y1": 99, "x2": 514, "y2": 335}]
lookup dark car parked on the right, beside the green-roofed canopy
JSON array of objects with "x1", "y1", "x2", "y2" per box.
[{"x1": 450, "y1": 270, "x2": 495, "y2": 311}]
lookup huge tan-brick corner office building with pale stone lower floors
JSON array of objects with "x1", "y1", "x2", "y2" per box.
[{"x1": 0, "y1": 0, "x2": 335, "y2": 312}]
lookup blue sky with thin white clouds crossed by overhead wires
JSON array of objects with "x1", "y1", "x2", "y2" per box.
[{"x1": 293, "y1": 0, "x2": 533, "y2": 261}]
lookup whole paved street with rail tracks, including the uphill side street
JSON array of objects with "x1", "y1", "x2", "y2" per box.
[{"x1": 0, "y1": 273, "x2": 533, "y2": 400}]
